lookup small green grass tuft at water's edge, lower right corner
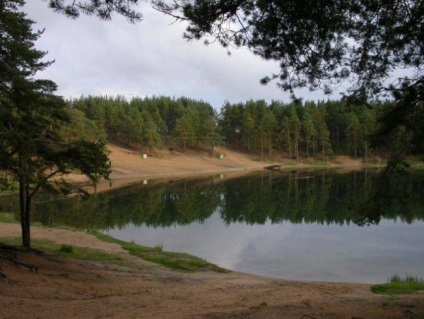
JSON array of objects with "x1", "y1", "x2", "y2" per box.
[{"x1": 371, "y1": 275, "x2": 424, "y2": 295}]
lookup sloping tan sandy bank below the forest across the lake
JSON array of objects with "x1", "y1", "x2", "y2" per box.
[{"x1": 67, "y1": 144, "x2": 364, "y2": 191}]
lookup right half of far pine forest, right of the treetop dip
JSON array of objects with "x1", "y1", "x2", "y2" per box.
[{"x1": 220, "y1": 101, "x2": 392, "y2": 160}]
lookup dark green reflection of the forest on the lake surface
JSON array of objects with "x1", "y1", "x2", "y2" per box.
[{"x1": 10, "y1": 171, "x2": 424, "y2": 230}]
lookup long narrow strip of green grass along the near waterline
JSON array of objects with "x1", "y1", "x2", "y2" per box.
[{"x1": 94, "y1": 232, "x2": 228, "y2": 272}]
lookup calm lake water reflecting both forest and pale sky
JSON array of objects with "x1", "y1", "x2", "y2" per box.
[{"x1": 4, "y1": 171, "x2": 424, "y2": 283}]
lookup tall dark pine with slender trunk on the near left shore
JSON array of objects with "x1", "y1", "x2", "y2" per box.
[{"x1": 0, "y1": 0, "x2": 109, "y2": 248}]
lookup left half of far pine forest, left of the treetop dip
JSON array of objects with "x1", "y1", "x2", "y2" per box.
[{"x1": 69, "y1": 96, "x2": 221, "y2": 154}]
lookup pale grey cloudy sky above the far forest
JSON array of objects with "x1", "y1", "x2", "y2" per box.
[{"x1": 25, "y1": 0, "x2": 338, "y2": 108}]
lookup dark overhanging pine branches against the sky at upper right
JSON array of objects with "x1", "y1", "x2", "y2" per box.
[{"x1": 153, "y1": 0, "x2": 424, "y2": 96}]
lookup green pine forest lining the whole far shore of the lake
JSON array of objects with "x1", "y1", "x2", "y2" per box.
[{"x1": 69, "y1": 96, "x2": 406, "y2": 162}]
